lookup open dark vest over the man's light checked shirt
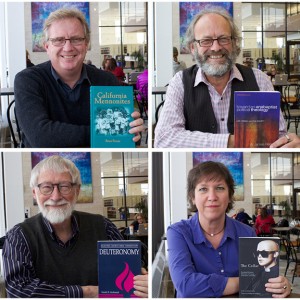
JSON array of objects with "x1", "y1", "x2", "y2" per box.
[{"x1": 182, "y1": 64, "x2": 259, "y2": 134}]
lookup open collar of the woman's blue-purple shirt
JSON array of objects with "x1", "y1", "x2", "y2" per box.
[{"x1": 191, "y1": 212, "x2": 236, "y2": 245}]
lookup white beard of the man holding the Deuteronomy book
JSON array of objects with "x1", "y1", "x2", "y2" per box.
[{"x1": 37, "y1": 198, "x2": 76, "y2": 224}]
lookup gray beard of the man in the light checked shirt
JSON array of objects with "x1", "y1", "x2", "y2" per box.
[{"x1": 193, "y1": 48, "x2": 238, "y2": 77}]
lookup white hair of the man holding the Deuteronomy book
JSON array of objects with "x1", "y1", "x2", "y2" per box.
[{"x1": 30, "y1": 155, "x2": 81, "y2": 188}]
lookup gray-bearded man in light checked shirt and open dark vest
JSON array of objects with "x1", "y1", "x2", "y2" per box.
[{"x1": 154, "y1": 6, "x2": 300, "y2": 148}]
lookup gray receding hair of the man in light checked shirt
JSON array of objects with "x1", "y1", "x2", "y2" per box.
[{"x1": 185, "y1": 5, "x2": 241, "y2": 55}]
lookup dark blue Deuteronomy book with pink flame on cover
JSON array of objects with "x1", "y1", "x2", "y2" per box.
[{"x1": 98, "y1": 240, "x2": 141, "y2": 298}]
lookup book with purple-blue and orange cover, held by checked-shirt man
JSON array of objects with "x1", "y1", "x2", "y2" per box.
[{"x1": 234, "y1": 91, "x2": 281, "y2": 148}]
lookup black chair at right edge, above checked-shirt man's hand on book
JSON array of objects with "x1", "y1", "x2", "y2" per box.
[{"x1": 282, "y1": 83, "x2": 300, "y2": 134}]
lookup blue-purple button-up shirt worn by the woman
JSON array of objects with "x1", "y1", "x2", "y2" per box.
[{"x1": 167, "y1": 213, "x2": 256, "y2": 298}]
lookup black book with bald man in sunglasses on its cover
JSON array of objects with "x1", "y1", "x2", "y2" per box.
[{"x1": 239, "y1": 237, "x2": 280, "y2": 298}]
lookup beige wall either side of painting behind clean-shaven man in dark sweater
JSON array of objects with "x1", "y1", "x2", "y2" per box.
[{"x1": 24, "y1": 2, "x2": 101, "y2": 68}]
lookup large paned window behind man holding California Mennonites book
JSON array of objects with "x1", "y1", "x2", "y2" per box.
[{"x1": 99, "y1": 2, "x2": 148, "y2": 70}]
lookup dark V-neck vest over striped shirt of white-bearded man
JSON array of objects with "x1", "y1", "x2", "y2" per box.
[{"x1": 20, "y1": 211, "x2": 107, "y2": 286}]
